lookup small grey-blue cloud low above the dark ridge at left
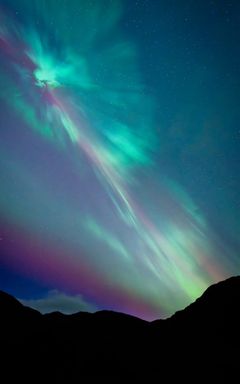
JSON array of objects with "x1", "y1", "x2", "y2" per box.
[{"x1": 19, "y1": 289, "x2": 98, "y2": 315}]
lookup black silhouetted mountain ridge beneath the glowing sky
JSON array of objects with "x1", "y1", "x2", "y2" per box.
[{"x1": 0, "y1": 276, "x2": 240, "y2": 383}]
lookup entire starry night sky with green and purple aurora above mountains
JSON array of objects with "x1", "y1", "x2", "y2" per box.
[{"x1": 0, "y1": 0, "x2": 240, "y2": 320}]
